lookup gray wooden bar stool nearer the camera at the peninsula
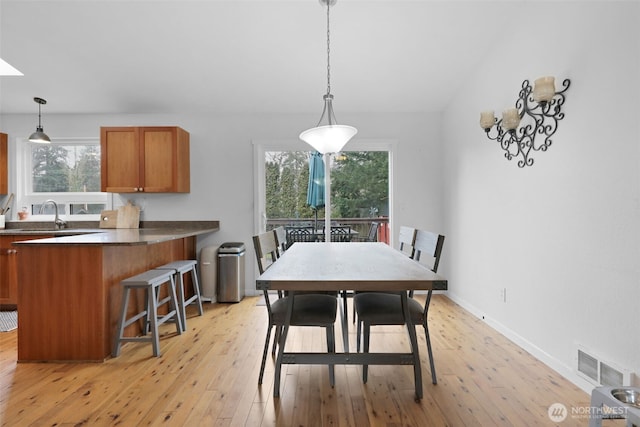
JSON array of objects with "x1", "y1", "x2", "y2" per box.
[{"x1": 112, "y1": 269, "x2": 182, "y2": 357}]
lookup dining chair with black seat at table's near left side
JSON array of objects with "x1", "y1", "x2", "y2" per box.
[{"x1": 253, "y1": 230, "x2": 338, "y2": 387}]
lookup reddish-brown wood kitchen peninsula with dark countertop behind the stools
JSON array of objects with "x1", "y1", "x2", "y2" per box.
[{"x1": 7, "y1": 221, "x2": 219, "y2": 362}]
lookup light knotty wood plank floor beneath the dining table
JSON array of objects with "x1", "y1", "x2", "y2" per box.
[{"x1": 0, "y1": 295, "x2": 608, "y2": 426}]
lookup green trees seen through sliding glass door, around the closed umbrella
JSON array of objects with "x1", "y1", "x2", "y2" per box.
[{"x1": 265, "y1": 151, "x2": 389, "y2": 219}]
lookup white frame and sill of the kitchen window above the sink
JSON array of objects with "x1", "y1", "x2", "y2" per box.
[{"x1": 14, "y1": 137, "x2": 113, "y2": 221}]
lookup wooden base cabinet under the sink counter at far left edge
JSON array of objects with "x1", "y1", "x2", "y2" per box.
[{"x1": 0, "y1": 234, "x2": 53, "y2": 310}]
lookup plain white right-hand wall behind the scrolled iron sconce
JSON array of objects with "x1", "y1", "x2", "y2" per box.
[{"x1": 443, "y1": 2, "x2": 640, "y2": 391}]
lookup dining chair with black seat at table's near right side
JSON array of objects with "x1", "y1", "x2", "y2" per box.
[{"x1": 353, "y1": 230, "x2": 444, "y2": 384}]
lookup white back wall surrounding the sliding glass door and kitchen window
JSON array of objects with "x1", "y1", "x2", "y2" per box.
[{"x1": 1, "y1": 110, "x2": 442, "y2": 294}]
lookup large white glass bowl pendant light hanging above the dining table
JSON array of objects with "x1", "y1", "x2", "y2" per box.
[{"x1": 300, "y1": 0, "x2": 358, "y2": 154}]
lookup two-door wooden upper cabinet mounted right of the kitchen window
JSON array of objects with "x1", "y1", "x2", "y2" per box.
[{"x1": 100, "y1": 126, "x2": 191, "y2": 193}]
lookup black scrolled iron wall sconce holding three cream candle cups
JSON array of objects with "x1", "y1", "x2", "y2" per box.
[{"x1": 480, "y1": 77, "x2": 571, "y2": 168}]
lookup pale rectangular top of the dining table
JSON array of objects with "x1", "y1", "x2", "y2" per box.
[{"x1": 256, "y1": 242, "x2": 447, "y2": 291}]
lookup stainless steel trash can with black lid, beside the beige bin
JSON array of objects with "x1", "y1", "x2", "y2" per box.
[{"x1": 218, "y1": 242, "x2": 245, "y2": 302}]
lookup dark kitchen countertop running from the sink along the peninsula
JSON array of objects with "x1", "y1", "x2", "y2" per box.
[{"x1": 0, "y1": 221, "x2": 220, "y2": 245}]
